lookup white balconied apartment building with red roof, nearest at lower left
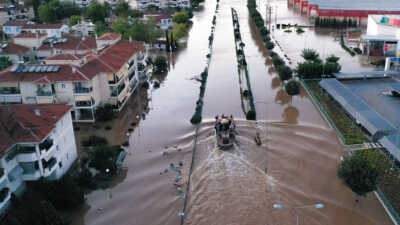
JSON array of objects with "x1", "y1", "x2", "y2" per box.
[{"x1": 0, "y1": 104, "x2": 77, "y2": 211}]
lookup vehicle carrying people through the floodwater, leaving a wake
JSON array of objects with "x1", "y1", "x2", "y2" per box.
[{"x1": 215, "y1": 115, "x2": 236, "y2": 150}]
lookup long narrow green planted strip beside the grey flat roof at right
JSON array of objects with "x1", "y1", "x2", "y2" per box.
[{"x1": 304, "y1": 79, "x2": 368, "y2": 145}]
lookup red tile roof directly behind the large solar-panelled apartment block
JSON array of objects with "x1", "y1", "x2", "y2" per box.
[{"x1": 38, "y1": 37, "x2": 97, "y2": 51}]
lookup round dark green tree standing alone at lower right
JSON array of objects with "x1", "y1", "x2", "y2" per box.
[{"x1": 338, "y1": 151, "x2": 379, "y2": 196}]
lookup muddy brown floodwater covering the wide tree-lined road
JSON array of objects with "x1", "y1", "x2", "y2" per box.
[{"x1": 72, "y1": 0, "x2": 392, "y2": 225}]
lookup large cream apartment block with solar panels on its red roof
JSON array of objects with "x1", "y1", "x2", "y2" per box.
[{"x1": 0, "y1": 40, "x2": 147, "y2": 122}]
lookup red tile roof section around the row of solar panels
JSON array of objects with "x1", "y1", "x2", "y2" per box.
[{"x1": 0, "y1": 64, "x2": 92, "y2": 83}]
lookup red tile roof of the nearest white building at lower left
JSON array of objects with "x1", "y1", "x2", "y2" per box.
[{"x1": 0, "y1": 104, "x2": 72, "y2": 154}]
